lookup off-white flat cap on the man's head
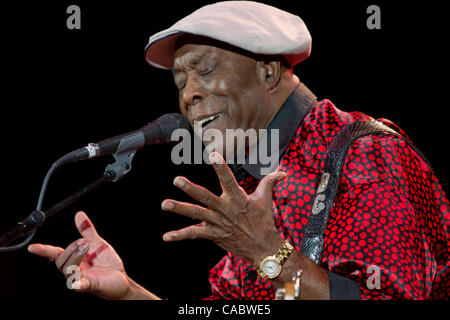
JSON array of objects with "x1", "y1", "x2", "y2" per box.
[{"x1": 145, "y1": 1, "x2": 311, "y2": 69}]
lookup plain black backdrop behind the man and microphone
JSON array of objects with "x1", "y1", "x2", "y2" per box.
[{"x1": 0, "y1": 0, "x2": 450, "y2": 300}]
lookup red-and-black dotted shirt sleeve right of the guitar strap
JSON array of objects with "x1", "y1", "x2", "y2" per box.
[{"x1": 322, "y1": 136, "x2": 450, "y2": 299}]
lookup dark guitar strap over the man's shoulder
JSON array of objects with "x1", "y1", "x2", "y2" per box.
[{"x1": 300, "y1": 120, "x2": 431, "y2": 264}]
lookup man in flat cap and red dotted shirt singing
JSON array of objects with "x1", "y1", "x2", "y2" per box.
[{"x1": 29, "y1": 1, "x2": 450, "y2": 299}]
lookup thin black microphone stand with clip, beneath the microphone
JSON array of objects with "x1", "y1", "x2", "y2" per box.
[{"x1": 0, "y1": 137, "x2": 141, "y2": 253}]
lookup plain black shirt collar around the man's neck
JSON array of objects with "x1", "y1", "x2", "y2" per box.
[{"x1": 230, "y1": 83, "x2": 317, "y2": 181}]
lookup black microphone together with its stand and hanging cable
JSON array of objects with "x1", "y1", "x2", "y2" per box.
[{"x1": 0, "y1": 113, "x2": 189, "y2": 253}]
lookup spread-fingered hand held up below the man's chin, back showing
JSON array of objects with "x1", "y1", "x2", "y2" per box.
[{"x1": 161, "y1": 152, "x2": 286, "y2": 264}]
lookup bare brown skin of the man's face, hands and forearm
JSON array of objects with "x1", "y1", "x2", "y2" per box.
[{"x1": 29, "y1": 38, "x2": 329, "y2": 299}]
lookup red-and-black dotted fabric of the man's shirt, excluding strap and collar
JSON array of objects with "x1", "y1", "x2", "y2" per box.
[{"x1": 207, "y1": 100, "x2": 450, "y2": 299}]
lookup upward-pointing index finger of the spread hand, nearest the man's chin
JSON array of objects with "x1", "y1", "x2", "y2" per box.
[{"x1": 209, "y1": 152, "x2": 246, "y2": 200}]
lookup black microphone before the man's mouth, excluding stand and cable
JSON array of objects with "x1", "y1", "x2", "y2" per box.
[{"x1": 60, "y1": 113, "x2": 189, "y2": 163}]
